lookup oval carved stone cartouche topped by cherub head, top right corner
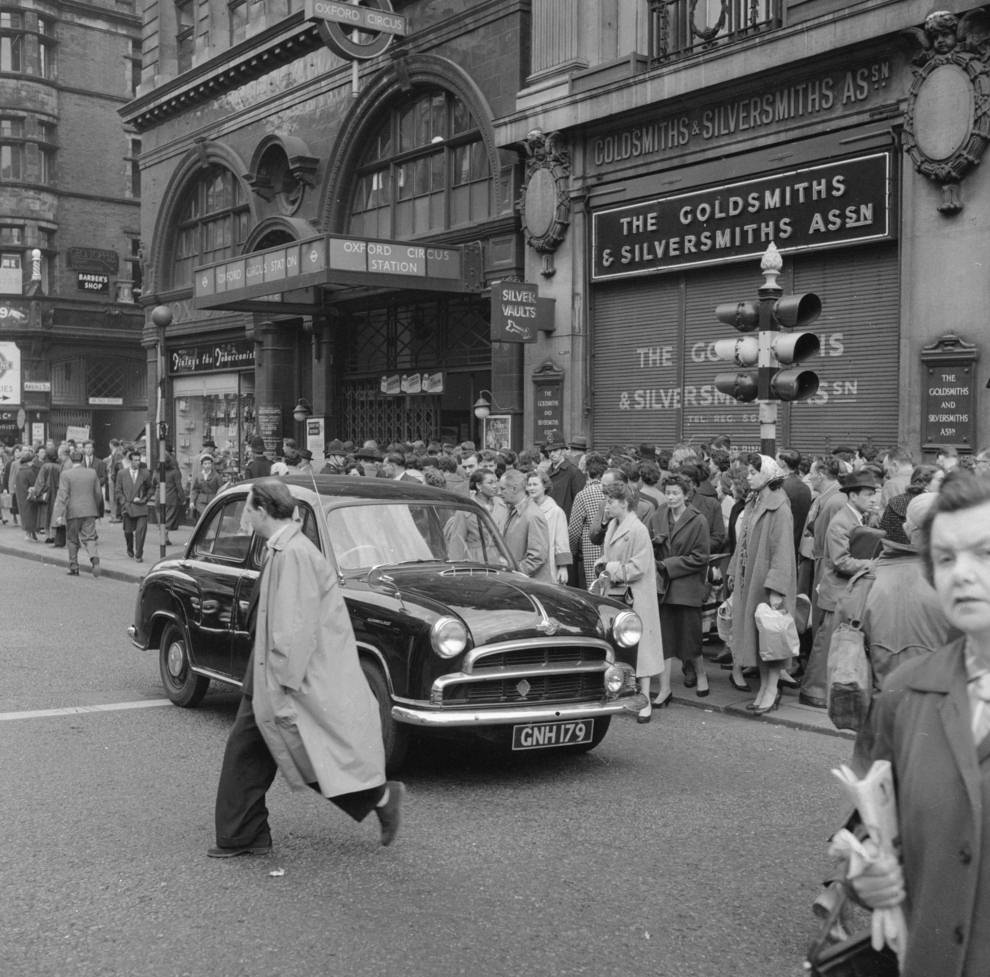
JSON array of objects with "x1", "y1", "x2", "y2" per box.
[{"x1": 904, "y1": 8, "x2": 990, "y2": 215}]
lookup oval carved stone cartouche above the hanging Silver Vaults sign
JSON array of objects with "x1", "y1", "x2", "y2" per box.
[{"x1": 518, "y1": 129, "x2": 571, "y2": 278}]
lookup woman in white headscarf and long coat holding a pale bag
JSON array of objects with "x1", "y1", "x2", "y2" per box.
[{"x1": 729, "y1": 454, "x2": 797, "y2": 716}]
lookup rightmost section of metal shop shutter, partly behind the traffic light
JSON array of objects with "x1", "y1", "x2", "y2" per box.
[{"x1": 778, "y1": 245, "x2": 900, "y2": 453}]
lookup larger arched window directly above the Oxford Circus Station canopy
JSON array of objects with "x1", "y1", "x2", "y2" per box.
[{"x1": 348, "y1": 89, "x2": 492, "y2": 240}]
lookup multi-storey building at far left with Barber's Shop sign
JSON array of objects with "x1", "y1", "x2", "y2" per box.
[{"x1": 0, "y1": 0, "x2": 147, "y2": 451}]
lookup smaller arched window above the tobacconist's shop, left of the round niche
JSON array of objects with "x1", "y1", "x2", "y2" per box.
[{"x1": 168, "y1": 164, "x2": 250, "y2": 288}]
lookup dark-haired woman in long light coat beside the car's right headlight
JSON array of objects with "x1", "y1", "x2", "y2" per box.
[{"x1": 596, "y1": 482, "x2": 664, "y2": 723}]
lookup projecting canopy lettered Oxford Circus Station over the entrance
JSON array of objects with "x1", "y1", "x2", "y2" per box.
[{"x1": 193, "y1": 234, "x2": 484, "y2": 315}]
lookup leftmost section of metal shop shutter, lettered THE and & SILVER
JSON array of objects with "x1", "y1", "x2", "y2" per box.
[{"x1": 591, "y1": 275, "x2": 683, "y2": 449}]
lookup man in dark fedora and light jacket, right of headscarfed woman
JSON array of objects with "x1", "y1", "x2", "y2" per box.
[{"x1": 799, "y1": 471, "x2": 880, "y2": 709}]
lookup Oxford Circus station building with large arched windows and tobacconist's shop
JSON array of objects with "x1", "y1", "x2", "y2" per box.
[{"x1": 123, "y1": 0, "x2": 528, "y2": 488}]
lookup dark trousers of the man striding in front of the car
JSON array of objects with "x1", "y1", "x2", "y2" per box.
[{"x1": 215, "y1": 692, "x2": 385, "y2": 848}]
